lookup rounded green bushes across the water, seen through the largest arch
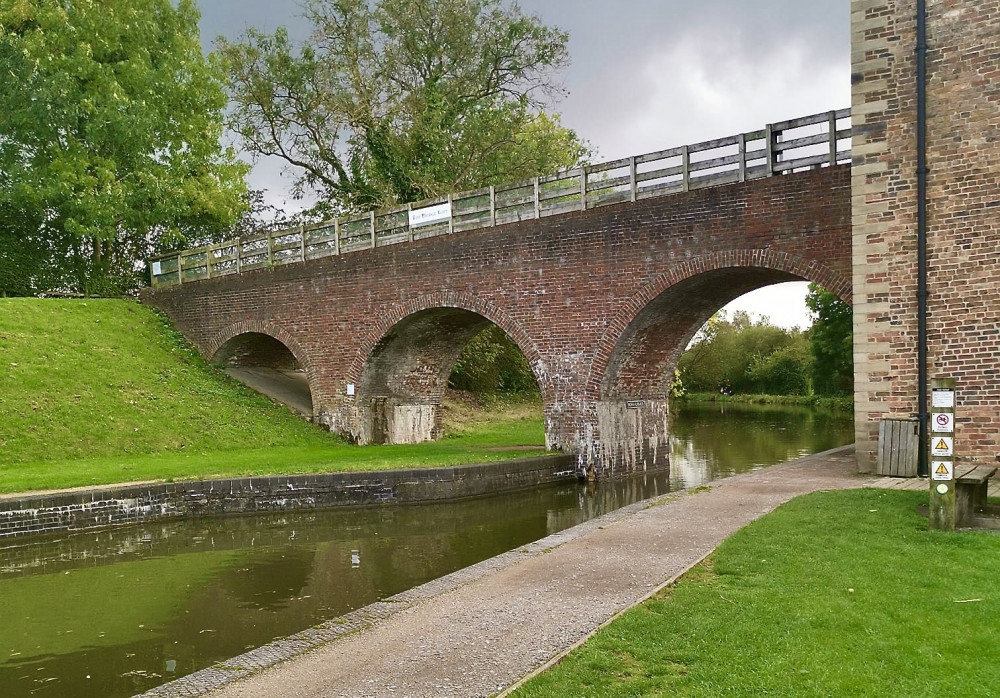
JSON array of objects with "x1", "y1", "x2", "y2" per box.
[{"x1": 678, "y1": 311, "x2": 809, "y2": 395}]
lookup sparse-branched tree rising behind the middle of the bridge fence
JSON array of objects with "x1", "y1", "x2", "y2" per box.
[{"x1": 218, "y1": 0, "x2": 588, "y2": 214}]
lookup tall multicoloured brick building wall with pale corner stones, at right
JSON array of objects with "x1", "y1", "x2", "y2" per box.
[{"x1": 852, "y1": 0, "x2": 1000, "y2": 470}]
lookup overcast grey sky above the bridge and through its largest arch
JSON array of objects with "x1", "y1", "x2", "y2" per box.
[{"x1": 199, "y1": 0, "x2": 851, "y2": 326}]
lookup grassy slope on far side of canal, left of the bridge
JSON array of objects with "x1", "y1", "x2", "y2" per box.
[{"x1": 0, "y1": 299, "x2": 544, "y2": 492}]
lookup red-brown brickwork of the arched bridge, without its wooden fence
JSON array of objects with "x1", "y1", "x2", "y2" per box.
[{"x1": 144, "y1": 166, "x2": 851, "y2": 469}]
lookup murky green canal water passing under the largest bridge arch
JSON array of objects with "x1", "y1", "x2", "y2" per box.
[{"x1": 0, "y1": 406, "x2": 852, "y2": 698}]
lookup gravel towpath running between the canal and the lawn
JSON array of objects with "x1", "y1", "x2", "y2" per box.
[{"x1": 151, "y1": 447, "x2": 875, "y2": 698}]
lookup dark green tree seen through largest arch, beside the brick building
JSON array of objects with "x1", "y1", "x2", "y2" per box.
[{"x1": 806, "y1": 284, "x2": 854, "y2": 395}]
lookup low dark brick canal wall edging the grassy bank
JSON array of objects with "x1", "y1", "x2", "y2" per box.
[{"x1": 0, "y1": 455, "x2": 576, "y2": 540}]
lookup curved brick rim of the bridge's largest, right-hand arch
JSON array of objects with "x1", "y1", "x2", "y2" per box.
[{"x1": 586, "y1": 249, "x2": 852, "y2": 399}]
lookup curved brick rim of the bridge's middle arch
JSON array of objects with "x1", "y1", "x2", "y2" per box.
[{"x1": 348, "y1": 291, "x2": 553, "y2": 404}]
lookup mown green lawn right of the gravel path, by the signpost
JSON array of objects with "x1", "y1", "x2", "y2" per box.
[{"x1": 514, "y1": 490, "x2": 1000, "y2": 698}]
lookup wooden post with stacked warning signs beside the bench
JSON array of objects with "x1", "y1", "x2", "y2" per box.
[{"x1": 927, "y1": 378, "x2": 955, "y2": 531}]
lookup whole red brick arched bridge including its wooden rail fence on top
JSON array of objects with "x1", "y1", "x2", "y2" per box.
[{"x1": 145, "y1": 110, "x2": 851, "y2": 470}]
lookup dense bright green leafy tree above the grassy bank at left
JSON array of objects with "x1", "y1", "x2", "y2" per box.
[{"x1": 0, "y1": 0, "x2": 246, "y2": 293}]
